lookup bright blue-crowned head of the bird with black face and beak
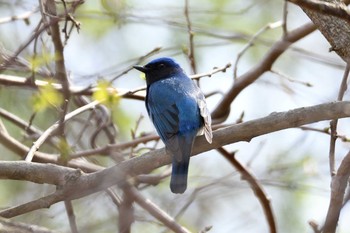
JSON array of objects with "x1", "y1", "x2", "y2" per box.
[{"x1": 134, "y1": 57, "x2": 183, "y2": 86}]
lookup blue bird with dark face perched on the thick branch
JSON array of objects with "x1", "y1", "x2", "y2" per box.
[{"x1": 134, "y1": 57, "x2": 213, "y2": 194}]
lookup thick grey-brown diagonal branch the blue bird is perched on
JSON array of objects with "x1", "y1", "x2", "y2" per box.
[{"x1": 0, "y1": 101, "x2": 350, "y2": 218}]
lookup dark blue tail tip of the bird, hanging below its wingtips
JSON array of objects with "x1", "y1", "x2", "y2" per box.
[{"x1": 170, "y1": 155, "x2": 190, "y2": 193}]
